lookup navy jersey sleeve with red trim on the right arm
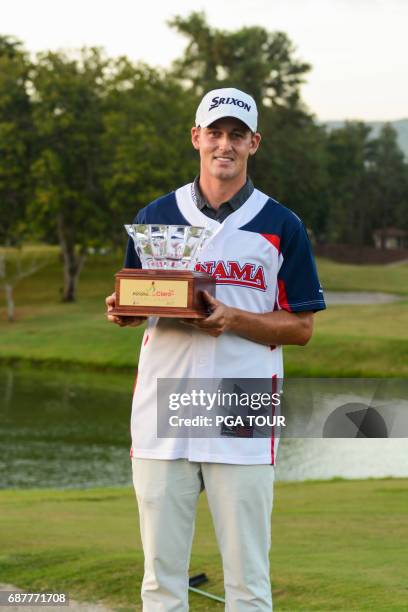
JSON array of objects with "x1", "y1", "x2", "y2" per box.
[{"x1": 276, "y1": 223, "x2": 326, "y2": 312}]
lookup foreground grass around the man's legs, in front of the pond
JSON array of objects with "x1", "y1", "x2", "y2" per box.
[{"x1": 0, "y1": 479, "x2": 408, "y2": 612}]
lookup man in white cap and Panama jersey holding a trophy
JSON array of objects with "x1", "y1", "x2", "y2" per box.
[{"x1": 107, "y1": 89, "x2": 325, "y2": 612}]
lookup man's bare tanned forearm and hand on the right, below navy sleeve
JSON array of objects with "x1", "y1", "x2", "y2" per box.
[{"x1": 184, "y1": 291, "x2": 313, "y2": 346}]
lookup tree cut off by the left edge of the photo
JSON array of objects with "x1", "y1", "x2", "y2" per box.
[{"x1": 0, "y1": 36, "x2": 38, "y2": 322}]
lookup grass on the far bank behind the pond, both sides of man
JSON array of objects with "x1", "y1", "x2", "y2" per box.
[{"x1": 0, "y1": 250, "x2": 408, "y2": 377}]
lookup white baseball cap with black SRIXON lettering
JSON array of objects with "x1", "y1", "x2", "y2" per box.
[{"x1": 196, "y1": 87, "x2": 258, "y2": 132}]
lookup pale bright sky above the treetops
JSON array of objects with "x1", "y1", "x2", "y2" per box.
[{"x1": 0, "y1": 0, "x2": 408, "y2": 121}]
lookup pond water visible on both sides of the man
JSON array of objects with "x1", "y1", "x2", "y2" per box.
[{"x1": 0, "y1": 368, "x2": 408, "y2": 488}]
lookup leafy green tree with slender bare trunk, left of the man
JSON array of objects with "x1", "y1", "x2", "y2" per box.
[{"x1": 30, "y1": 49, "x2": 108, "y2": 302}]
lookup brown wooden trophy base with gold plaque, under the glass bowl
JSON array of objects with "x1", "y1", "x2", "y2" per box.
[{"x1": 112, "y1": 268, "x2": 215, "y2": 319}]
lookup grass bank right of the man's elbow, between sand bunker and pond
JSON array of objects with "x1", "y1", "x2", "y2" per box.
[{"x1": 284, "y1": 301, "x2": 408, "y2": 378}]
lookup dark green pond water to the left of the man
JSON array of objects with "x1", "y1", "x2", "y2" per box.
[{"x1": 0, "y1": 368, "x2": 133, "y2": 488}]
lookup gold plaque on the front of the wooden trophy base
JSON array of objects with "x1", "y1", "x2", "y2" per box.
[{"x1": 119, "y1": 278, "x2": 188, "y2": 308}]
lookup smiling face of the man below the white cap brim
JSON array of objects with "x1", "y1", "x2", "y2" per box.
[{"x1": 191, "y1": 117, "x2": 261, "y2": 181}]
